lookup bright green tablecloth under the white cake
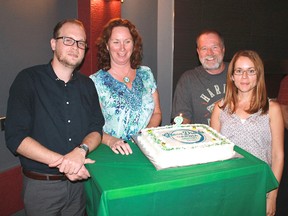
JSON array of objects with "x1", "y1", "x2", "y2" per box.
[{"x1": 85, "y1": 144, "x2": 278, "y2": 216}]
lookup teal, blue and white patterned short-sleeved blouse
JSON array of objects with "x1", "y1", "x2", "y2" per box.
[{"x1": 90, "y1": 66, "x2": 157, "y2": 140}]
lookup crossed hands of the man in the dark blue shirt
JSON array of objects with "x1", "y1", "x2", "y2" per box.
[{"x1": 49, "y1": 147, "x2": 95, "y2": 175}]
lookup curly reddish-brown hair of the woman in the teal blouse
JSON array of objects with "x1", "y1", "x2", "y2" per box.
[{"x1": 96, "y1": 18, "x2": 143, "y2": 70}]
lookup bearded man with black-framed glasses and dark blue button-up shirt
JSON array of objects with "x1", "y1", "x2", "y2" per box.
[{"x1": 5, "y1": 19, "x2": 104, "y2": 216}]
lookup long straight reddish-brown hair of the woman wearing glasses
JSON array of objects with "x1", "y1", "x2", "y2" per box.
[{"x1": 220, "y1": 50, "x2": 269, "y2": 114}]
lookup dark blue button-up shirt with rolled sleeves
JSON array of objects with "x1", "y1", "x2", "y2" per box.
[{"x1": 5, "y1": 63, "x2": 104, "y2": 174}]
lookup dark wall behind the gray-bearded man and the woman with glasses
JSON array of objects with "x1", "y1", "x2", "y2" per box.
[{"x1": 173, "y1": 0, "x2": 288, "y2": 97}]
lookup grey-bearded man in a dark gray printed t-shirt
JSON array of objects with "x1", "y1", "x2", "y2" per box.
[{"x1": 171, "y1": 29, "x2": 228, "y2": 125}]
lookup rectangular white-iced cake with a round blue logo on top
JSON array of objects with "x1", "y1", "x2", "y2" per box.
[{"x1": 137, "y1": 124, "x2": 235, "y2": 170}]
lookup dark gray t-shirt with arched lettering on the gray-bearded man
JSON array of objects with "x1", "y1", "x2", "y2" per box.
[{"x1": 171, "y1": 63, "x2": 228, "y2": 125}]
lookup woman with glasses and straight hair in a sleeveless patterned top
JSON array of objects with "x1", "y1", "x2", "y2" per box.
[{"x1": 211, "y1": 50, "x2": 284, "y2": 215}]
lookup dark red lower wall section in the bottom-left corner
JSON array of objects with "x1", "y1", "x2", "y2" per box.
[{"x1": 0, "y1": 166, "x2": 24, "y2": 216}]
